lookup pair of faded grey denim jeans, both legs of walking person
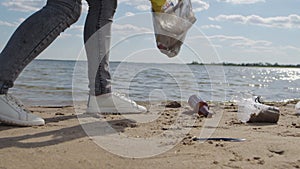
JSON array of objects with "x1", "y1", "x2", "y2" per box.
[{"x1": 0, "y1": 0, "x2": 117, "y2": 95}]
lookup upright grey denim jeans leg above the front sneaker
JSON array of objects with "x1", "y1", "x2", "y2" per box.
[{"x1": 84, "y1": 0, "x2": 117, "y2": 96}]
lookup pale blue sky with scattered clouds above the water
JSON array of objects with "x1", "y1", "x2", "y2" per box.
[{"x1": 0, "y1": 0, "x2": 300, "y2": 64}]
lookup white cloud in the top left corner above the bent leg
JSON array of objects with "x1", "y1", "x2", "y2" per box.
[{"x1": 1, "y1": 0, "x2": 45, "y2": 12}]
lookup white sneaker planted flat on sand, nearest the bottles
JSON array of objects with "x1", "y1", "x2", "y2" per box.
[{"x1": 87, "y1": 93, "x2": 147, "y2": 114}]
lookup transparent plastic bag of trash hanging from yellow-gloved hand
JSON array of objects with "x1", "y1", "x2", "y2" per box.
[{"x1": 151, "y1": 0, "x2": 196, "y2": 57}]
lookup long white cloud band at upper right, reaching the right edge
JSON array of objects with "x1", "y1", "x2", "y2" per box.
[{"x1": 209, "y1": 14, "x2": 300, "y2": 28}]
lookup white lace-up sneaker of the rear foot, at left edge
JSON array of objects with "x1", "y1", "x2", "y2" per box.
[{"x1": 0, "y1": 94, "x2": 45, "y2": 126}]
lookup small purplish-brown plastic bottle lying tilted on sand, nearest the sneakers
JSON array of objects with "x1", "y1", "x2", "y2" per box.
[{"x1": 188, "y1": 95, "x2": 213, "y2": 118}]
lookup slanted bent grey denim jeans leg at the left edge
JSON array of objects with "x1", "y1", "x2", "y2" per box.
[{"x1": 0, "y1": 0, "x2": 81, "y2": 94}]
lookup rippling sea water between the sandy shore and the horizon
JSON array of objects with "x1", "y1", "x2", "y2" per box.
[{"x1": 10, "y1": 60, "x2": 300, "y2": 105}]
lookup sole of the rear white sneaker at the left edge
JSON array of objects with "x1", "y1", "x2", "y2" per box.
[{"x1": 0, "y1": 114, "x2": 45, "y2": 127}]
